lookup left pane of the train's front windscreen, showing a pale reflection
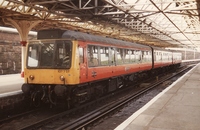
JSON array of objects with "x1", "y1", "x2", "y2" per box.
[{"x1": 27, "y1": 45, "x2": 39, "y2": 67}]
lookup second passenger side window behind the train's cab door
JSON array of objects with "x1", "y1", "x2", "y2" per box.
[{"x1": 100, "y1": 47, "x2": 109, "y2": 65}]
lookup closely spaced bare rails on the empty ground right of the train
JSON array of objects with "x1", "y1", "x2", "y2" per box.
[{"x1": 56, "y1": 66, "x2": 194, "y2": 130}]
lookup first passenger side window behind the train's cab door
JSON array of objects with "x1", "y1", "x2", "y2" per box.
[{"x1": 88, "y1": 45, "x2": 99, "y2": 67}]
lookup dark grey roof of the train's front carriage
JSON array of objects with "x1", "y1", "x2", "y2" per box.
[{"x1": 38, "y1": 29, "x2": 150, "y2": 49}]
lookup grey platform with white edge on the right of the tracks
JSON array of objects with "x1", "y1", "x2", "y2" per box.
[{"x1": 115, "y1": 64, "x2": 200, "y2": 130}]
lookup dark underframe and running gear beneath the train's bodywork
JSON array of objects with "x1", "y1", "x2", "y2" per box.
[{"x1": 22, "y1": 65, "x2": 179, "y2": 108}]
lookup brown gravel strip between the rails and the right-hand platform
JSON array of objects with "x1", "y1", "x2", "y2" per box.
[{"x1": 88, "y1": 82, "x2": 171, "y2": 130}]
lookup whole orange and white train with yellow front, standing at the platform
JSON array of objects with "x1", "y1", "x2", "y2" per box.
[{"x1": 22, "y1": 29, "x2": 182, "y2": 106}]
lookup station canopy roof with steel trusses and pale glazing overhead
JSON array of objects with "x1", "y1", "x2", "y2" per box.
[{"x1": 0, "y1": 0, "x2": 200, "y2": 49}]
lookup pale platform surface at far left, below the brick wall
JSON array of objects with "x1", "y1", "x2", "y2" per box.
[{"x1": 0, "y1": 74, "x2": 24, "y2": 94}]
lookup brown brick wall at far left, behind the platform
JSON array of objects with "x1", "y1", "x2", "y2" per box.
[{"x1": 0, "y1": 32, "x2": 21, "y2": 75}]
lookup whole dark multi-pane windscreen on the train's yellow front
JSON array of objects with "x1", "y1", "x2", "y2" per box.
[{"x1": 27, "y1": 40, "x2": 72, "y2": 68}]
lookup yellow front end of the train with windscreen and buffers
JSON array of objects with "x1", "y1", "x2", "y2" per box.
[{"x1": 22, "y1": 39, "x2": 79, "y2": 104}]
